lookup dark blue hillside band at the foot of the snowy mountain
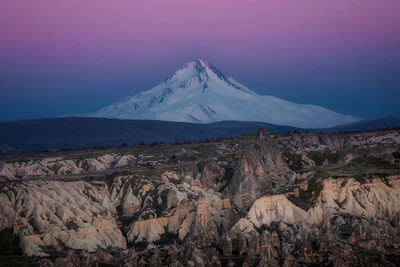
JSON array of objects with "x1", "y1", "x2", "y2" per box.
[{"x1": 0, "y1": 117, "x2": 400, "y2": 154}]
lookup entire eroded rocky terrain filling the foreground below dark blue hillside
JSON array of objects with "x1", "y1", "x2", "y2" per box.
[{"x1": 0, "y1": 130, "x2": 400, "y2": 266}]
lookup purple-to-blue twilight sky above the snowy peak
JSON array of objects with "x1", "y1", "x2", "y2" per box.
[{"x1": 0, "y1": 0, "x2": 400, "y2": 120}]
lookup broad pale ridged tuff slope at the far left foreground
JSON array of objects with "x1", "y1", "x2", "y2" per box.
[{"x1": 0, "y1": 181, "x2": 126, "y2": 256}]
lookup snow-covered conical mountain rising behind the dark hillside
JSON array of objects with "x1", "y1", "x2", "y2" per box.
[{"x1": 84, "y1": 59, "x2": 359, "y2": 128}]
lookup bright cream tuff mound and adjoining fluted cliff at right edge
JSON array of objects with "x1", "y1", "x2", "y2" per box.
[{"x1": 239, "y1": 177, "x2": 400, "y2": 231}]
